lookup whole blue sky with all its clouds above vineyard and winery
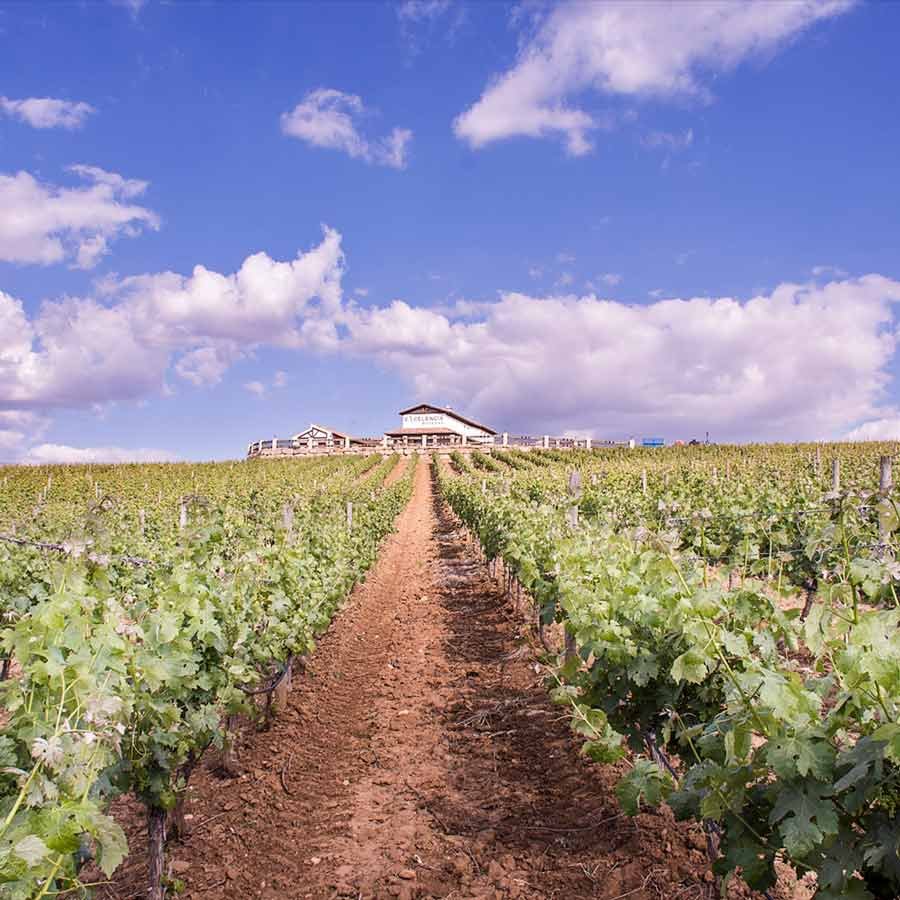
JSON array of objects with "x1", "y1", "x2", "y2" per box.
[{"x1": 0, "y1": 0, "x2": 900, "y2": 462}]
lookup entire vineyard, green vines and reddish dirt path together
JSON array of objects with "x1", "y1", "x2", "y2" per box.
[{"x1": 0, "y1": 444, "x2": 900, "y2": 900}]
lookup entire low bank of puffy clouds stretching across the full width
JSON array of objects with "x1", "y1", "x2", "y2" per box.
[{"x1": 0, "y1": 229, "x2": 900, "y2": 446}]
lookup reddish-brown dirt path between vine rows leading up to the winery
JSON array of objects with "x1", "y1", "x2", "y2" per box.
[{"x1": 106, "y1": 461, "x2": 713, "y2": 900}]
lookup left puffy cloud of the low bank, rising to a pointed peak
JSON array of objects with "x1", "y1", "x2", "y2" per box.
[{"x1": 0, "y1": 229, "x2": 343, "y2": 410}]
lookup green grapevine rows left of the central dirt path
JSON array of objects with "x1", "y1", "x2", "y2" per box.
[{"x1": 0, "y1": 456, "x2": 411, "y2": 898}]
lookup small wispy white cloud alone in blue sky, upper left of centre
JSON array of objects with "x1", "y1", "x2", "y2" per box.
[{"x1": 281, "y1": 88, "x2": 412, "y2": 169}]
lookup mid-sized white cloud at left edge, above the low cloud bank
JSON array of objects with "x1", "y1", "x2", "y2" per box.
[{"x1": 0, "y1": 166, "x2": 159, "y2": 269}]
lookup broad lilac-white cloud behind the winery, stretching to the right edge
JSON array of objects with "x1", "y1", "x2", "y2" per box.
[{"x1": 338, "y1": 275, "x2": 900, "y2": 440}]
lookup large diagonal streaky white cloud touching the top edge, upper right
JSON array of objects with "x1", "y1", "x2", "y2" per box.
[{"x1": 453, "y1": 0, "x2": 854, "y2": 156}]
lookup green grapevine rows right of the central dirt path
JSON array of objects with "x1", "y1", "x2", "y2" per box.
[{"x1": 442, "y1": 445, "x2": 900, "y2": 900}]
